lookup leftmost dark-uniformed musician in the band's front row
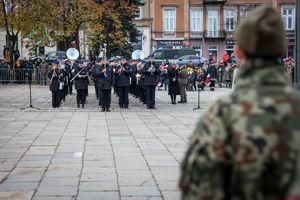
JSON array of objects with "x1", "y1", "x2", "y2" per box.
[{"x1": 48, "y1": 61, "x2": 61, "y2": 108}]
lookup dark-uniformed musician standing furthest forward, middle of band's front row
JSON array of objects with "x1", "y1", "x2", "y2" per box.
[{"x1": 95, "y1": 60, "x2": 115, "y2": 112}]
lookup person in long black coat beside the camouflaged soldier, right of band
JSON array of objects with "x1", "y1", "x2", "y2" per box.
[{"x1": 167, "y1": 65, "x2": 180, "y2": 104}]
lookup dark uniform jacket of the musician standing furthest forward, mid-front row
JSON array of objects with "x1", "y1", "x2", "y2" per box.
[{"x1": 94, "y1": 65, "x2": 115, "y2": 90}]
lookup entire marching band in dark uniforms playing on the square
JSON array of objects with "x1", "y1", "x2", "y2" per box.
[{"x1": 48, "y1": 51, "x2": 161, "y2": 112}]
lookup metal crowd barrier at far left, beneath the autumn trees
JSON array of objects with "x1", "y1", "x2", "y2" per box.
[{"x1": 0, "y1": 68, "x2": 49, "y2": 84}]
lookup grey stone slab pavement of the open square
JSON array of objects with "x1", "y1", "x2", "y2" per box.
[{"x1": 0, "y1": 85, "x2": 230, "y2": 200}]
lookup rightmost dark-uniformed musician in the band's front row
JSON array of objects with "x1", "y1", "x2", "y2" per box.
[{"x1": 141, "y1": 57, "x2": 160, "y2": 109}]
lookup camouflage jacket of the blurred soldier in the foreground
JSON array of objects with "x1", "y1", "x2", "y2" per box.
[{"x1": 180, "y1": 59, "x2": 300, "y2": 200}]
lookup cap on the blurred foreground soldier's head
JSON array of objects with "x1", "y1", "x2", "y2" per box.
[{"x1": 235, "y1": 7, "x2": 286, "y2": 57}]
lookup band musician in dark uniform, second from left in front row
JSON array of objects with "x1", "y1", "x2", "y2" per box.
[{"x1": 74, "y1": 60, "x2": 89, "y2": 108}]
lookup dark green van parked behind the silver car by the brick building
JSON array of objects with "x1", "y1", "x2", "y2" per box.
[{"x1": 147, "y1": 48, "x2": 197, "y2": 63}]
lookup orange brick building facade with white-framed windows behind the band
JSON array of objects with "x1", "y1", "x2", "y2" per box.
[{"x1": 150, "y1": 0, "x2": 296, "y2": 60}]
